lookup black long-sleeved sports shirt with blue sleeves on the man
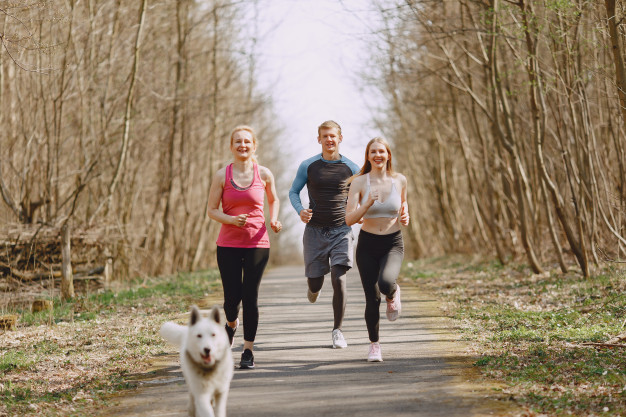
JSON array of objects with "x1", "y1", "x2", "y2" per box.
[{"x1": 289, "y1": 153, "x2": 360, "y2": 227}]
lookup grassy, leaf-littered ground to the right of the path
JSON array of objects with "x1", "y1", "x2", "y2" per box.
[{"x1": 405, "y1": 257, "x2": 626, "y2": 416}]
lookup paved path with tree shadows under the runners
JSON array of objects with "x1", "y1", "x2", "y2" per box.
[{"x1": 102, "y1": 266, "x2": 518, "y2": 417}]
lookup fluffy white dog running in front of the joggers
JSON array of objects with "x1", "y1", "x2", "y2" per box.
[{"x1": 161, "y1": 306, "x2": 234, "y2": 417}]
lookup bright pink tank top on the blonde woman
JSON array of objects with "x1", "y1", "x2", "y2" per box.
[{"x1": 217, "y1": 164, "x2": 270, "y2": 248}]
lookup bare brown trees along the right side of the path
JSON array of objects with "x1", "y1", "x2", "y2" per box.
[{"x1": 370, "y1": 0, "x2": 626, "y2": 276}]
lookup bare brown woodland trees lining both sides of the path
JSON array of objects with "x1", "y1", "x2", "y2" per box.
[{"x1": 0, "y1": 0, "x2": 626, "y2": 279}]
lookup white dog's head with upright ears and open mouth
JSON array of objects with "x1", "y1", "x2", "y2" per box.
[{"x1": 185, "y1": 306, "x2": 229, "y2": 368}]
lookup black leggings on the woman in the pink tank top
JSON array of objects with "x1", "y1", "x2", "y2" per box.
[{"x1": 217, "y1": 246, "x2": 270, "y2": 342}]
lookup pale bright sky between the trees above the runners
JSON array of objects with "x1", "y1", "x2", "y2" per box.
[{"x1": 251, "y1": 0, "x2": 381, "y2": 166}]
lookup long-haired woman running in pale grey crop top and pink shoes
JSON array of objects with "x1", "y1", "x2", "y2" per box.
[{"x1": 346, "y1": 137, "x2": 409, "y2": 362}]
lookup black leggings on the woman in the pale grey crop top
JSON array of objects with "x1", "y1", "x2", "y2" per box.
[{"x1": 356, "y1": 230, "x2": 404, "y2": 342}]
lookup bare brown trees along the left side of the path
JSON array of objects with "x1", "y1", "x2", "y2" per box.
[{"x1": 0, "y1": 0, "x2": 280, "y2": 290}]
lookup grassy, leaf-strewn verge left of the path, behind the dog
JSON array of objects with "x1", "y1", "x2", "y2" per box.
[{"x1": 0, "y1": 270, "x2": 221, "y2": 416}]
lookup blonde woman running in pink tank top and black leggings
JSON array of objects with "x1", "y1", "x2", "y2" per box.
[{"x1": 208, "y1": 126, "x2": 282, "y2": 369}]
